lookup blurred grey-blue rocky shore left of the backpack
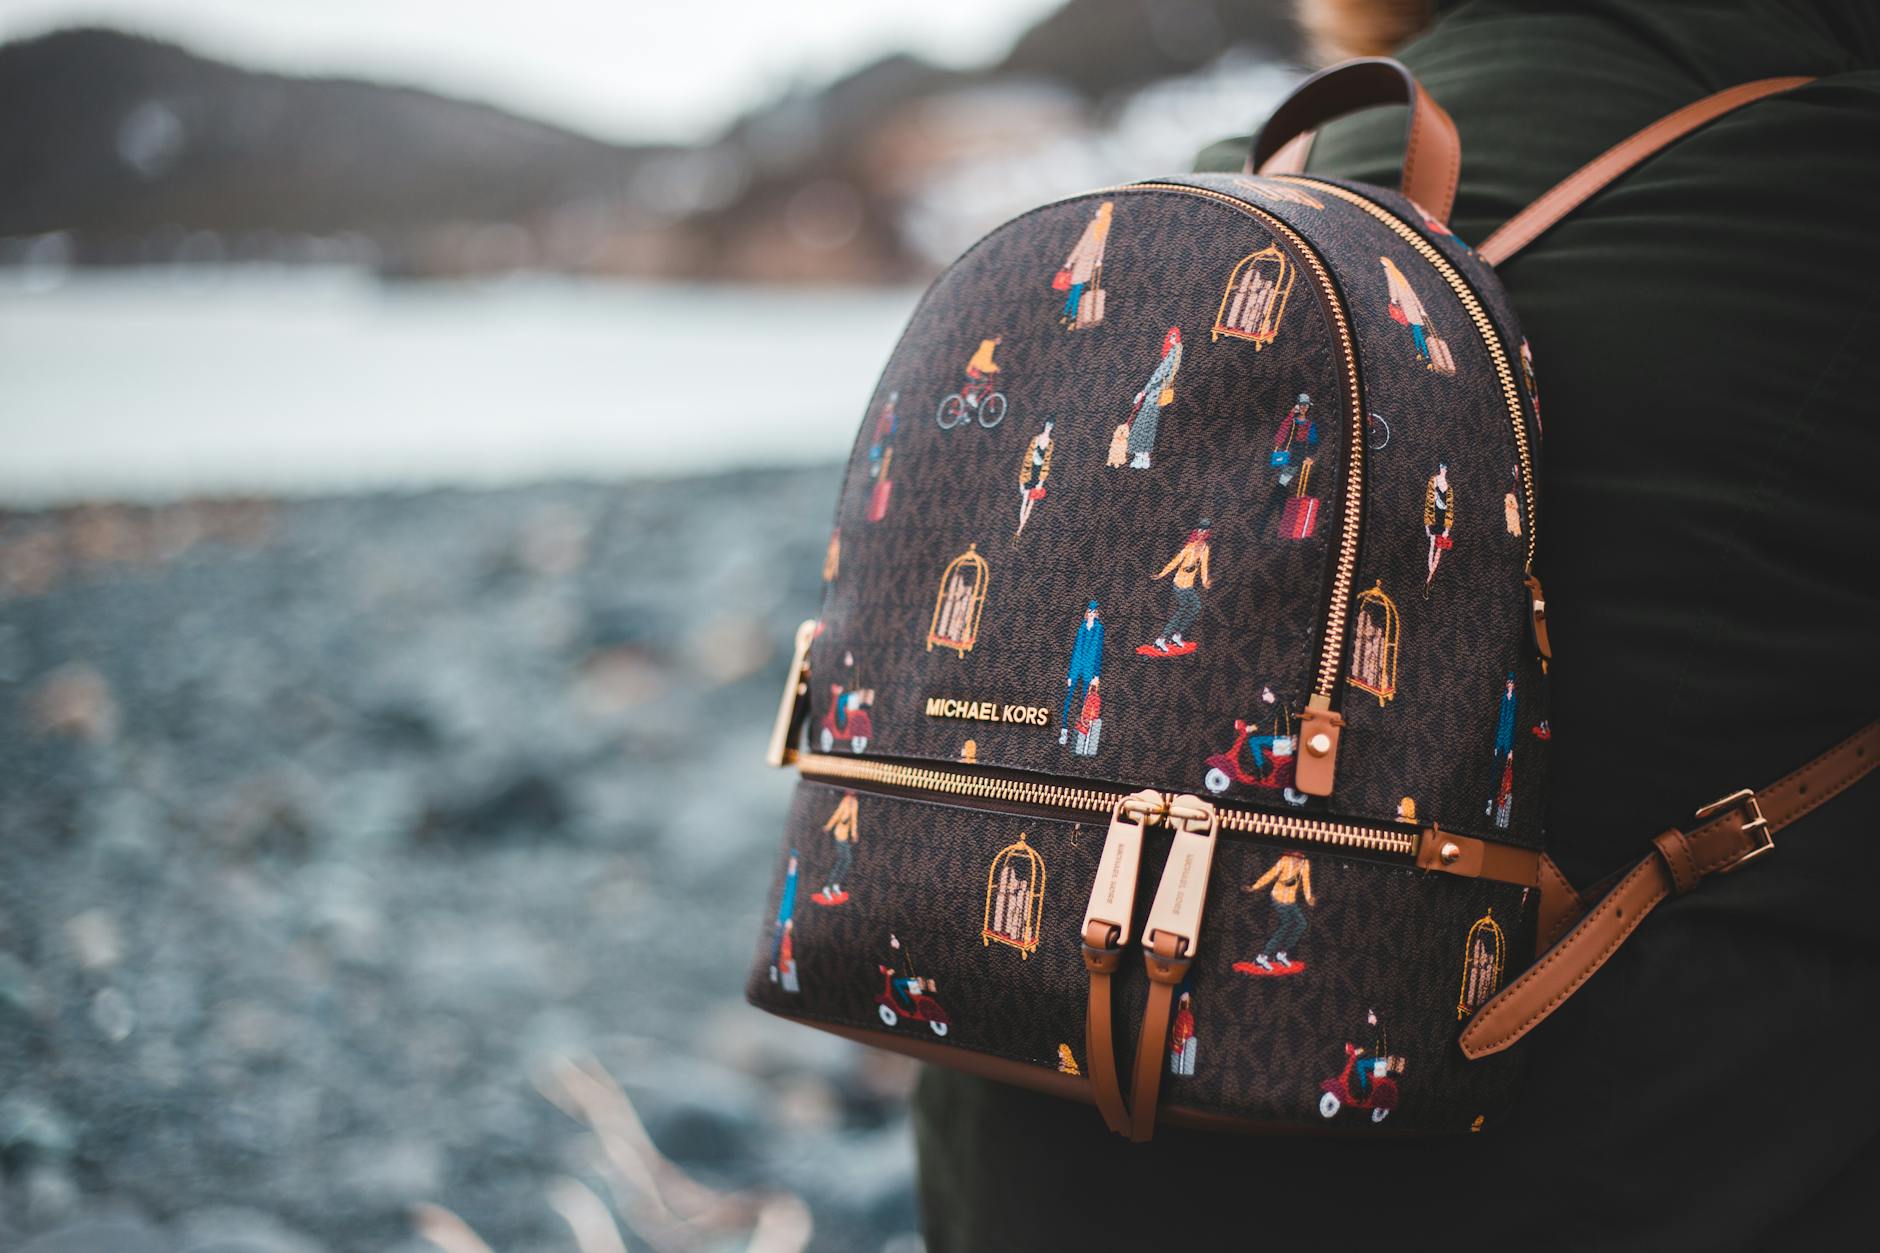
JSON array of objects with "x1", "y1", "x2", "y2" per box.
[{"x1": 0, "y1": 468, "x2": 919, "y2": 1253}]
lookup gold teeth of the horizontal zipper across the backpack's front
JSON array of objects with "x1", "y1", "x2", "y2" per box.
[{"x1": 797, "y1": 753, "x2": 1418, "y2": 856}]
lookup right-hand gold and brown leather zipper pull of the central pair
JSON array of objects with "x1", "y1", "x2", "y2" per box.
[{"x1": 1130, "y1": 796, "x2": 1220, "y2": 1144}]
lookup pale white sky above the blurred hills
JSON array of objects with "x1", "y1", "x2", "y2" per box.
[{"x1": 0, "y1": 0, "x2": 1060, "y2": 141}]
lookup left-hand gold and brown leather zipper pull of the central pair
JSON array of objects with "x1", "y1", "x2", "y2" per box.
[{"x1": 1083, "y1": 790, "x2": 1167, "y2": 1136}]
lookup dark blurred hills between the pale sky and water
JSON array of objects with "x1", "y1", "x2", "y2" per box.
[{"x1": 0, "y1": 0, "x2": 1297, "y2": 282}]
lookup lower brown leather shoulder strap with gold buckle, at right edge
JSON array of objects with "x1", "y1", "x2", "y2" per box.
[{"x1": 1461, "y1": 722, "x2": 1880, "y2": 1057}]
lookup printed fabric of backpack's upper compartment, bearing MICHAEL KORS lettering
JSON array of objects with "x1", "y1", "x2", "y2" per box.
[{"x1": 810, "y1": 177, "x2": 1549, "y2": 847}]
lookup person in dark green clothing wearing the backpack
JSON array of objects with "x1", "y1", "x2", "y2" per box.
[{"x1": 914, "y1": 0, "x2": 1880, "y2": 1253}]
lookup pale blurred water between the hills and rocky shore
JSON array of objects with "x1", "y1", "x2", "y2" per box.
[{"x1": 0, "y1": 271, "x2": 917, "y2": 504}]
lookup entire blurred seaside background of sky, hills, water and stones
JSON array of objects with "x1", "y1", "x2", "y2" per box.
[{"x1": 0, "y1": 0, "x2": 1305, "y2": 1253}]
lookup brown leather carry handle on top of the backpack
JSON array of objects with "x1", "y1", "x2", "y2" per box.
[{"x1": 1246, "y1": 56, "x2": 1463, "y2": 222}]
